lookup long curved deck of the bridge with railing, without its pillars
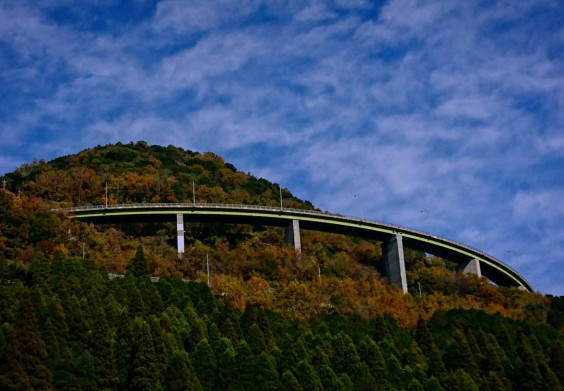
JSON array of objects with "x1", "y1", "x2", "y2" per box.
[{"x1": 64, "y1": 203, "x2": 533, "y2": 291}]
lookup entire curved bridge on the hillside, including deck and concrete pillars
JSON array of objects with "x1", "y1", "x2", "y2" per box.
[{"x1": 64, "y1": 203, "x2": 533, "y2": 292}]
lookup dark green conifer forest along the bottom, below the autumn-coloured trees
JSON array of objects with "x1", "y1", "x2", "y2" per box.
[{"x1": 0, "y1": 248, "x2": 564, "y2": 391}]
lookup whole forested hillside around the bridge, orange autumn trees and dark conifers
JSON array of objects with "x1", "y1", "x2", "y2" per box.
[{"x1": 0, "y1": 142, "x2": 564, "y2": 390}]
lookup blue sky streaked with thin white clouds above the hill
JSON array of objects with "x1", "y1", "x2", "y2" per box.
[{"x1": 0, "y1": 0, "x2": 564, "y2": 295}]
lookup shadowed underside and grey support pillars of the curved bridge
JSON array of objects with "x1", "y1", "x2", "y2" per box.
[{"x1": 72, "y1": 210, "x2": 532, "y2": 292}]
